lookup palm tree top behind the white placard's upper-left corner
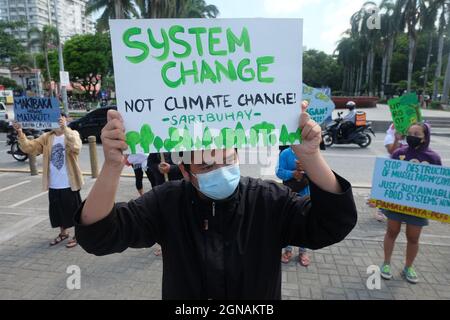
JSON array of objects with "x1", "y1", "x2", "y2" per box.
[{"x1": 86, "y1": 0, "x2": 139, "y2": 32}]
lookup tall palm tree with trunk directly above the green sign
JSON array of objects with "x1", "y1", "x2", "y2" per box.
[{"x1": 395, "y1": 0, "x2": 424, "y2": 92}]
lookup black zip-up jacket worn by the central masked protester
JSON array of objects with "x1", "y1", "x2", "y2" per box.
[{"x1": 75, "y1": 172, "x2": 357, "y2": 299}]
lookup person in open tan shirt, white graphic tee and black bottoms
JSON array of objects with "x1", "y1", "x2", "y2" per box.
[{"x1": 14, "y1": 114, "x2": 84, "y2": 248}]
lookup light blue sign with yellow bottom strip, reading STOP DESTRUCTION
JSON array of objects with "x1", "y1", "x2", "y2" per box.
[{"x1": 371, "y1": 158, "x2": 450, "y2": 223}]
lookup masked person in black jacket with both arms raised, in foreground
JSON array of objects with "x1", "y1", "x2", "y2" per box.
[{"x1": 71, "y1": 102, "x2": 357, "y2": 299}]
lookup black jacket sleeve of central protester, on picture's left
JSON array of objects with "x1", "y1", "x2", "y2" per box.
[{"x1": 75, "y1": 190, "x2": 162, "y2": 256}]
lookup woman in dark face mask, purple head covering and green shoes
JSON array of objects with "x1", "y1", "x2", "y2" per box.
[{"x1": 381, "y1": 123, "x2": 442, "y2": 284}]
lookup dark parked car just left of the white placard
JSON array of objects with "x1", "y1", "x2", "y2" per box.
[{"x1": 69, "y1": 106, "x2": 117, "y2": 141}]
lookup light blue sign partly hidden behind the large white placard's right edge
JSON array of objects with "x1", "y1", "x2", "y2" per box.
[{"x1": 303, "y1": 84, "x2": 336, "y2": 124}]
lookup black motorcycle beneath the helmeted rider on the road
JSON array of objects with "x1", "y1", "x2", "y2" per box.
[{"x1": 322, "y1": 112, "x2": 375, "y2": 148}]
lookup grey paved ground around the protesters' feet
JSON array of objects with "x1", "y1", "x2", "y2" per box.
[{"x1": 0, "y1": 168, "x2": 450, "y2": 300}]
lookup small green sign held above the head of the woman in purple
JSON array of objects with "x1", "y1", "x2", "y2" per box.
[{"x1": 388, "y1": 93, "x2": 422, "y2": 135}]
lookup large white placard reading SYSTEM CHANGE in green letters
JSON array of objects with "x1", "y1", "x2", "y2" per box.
[{"x1": 110, "y1": 19, "x2": 302, "y2": 153}]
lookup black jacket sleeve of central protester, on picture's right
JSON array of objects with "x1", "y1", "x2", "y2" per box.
[{"x1": 281, "y1": 175, "x2": 357, "y2": 250}]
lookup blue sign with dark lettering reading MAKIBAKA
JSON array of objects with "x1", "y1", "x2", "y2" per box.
[{"x1": 14, "y1": 97, "x2": 61, "y2": 129}]
